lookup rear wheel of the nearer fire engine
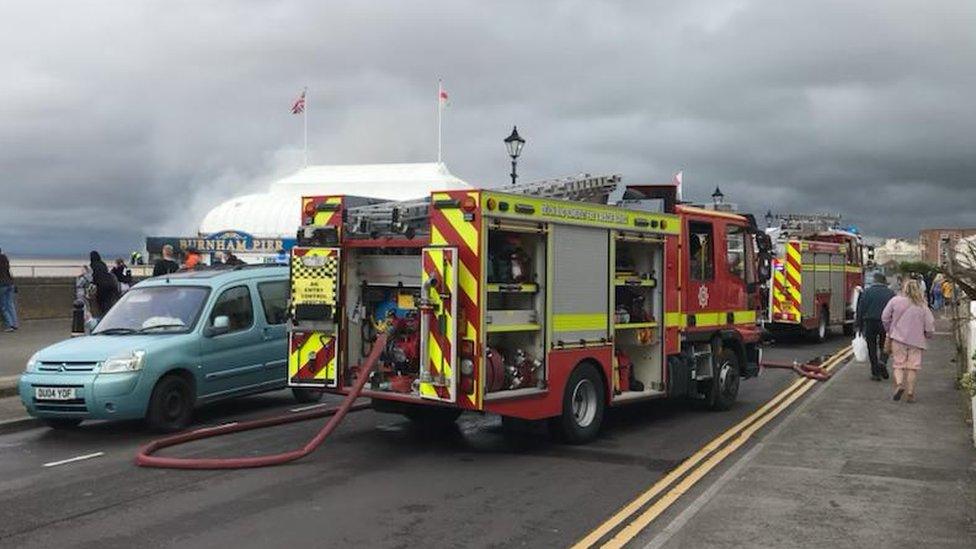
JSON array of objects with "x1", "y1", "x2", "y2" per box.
[{"x1": 549, "y1": 363, "x2": 607, "y2": 444}]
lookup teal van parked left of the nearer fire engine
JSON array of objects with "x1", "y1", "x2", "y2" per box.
[{"x1": 19, "y1": 266, "x2": 321, "y2": 431}]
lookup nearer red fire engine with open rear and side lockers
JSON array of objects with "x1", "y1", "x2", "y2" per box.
[{"x1": 288, "y1": 175, "x2": 768, "y2": 442}]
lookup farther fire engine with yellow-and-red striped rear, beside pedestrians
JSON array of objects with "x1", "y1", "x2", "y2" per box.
[{"x1": 765, "y1": 214, "x2": 864, "y2": 341}]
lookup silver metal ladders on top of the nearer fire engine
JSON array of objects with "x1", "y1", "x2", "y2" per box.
[{"x1": 345, "y1": 173, "x2": 621, "y2": 235}]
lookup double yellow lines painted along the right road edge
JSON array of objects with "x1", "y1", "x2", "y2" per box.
[{"x1": 573, "y1": 346, "x2": 852, "y2": 549}]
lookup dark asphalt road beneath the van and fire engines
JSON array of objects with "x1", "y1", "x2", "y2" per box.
[{"x1": 0, "y1": 336, "x2": 847, "y2": 548}]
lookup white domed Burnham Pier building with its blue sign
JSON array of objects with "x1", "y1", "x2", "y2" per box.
[{"x1": 146, "y1": 162, "x2": 471, "y2": 264}]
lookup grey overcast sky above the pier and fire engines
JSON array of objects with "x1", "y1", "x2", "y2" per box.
[{"x1": 0, "y1": 0, "x2": 976, "y2": 255}]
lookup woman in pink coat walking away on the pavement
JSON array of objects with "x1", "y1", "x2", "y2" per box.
[{"x1": 881, "y1": 278, "x2": 935, "y2": 402}]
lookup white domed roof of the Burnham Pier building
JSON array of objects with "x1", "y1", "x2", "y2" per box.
[{"x1": 200, "y1": 162, "x2": 471, "y2": 238}]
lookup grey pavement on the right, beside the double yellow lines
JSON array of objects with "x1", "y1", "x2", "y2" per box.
[{"x1": 634, "y1": 321, "x2": 976, "y2": 548}]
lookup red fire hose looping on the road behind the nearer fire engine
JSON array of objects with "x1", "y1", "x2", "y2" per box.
[{"x1": 136, "y1": 333, "x2": 387, "y2": 469}]
